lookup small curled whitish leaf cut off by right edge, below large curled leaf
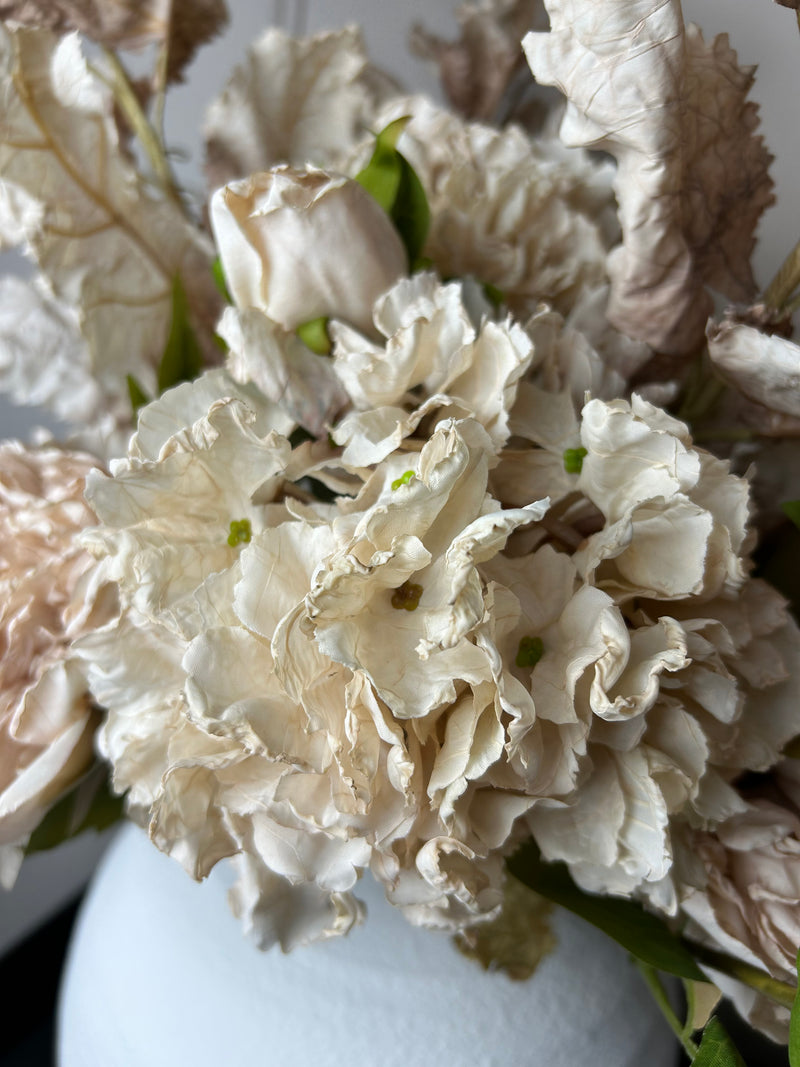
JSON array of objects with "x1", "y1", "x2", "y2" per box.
[{"x1": 707, "y1": 321, "x2": 800, "y2": 417}]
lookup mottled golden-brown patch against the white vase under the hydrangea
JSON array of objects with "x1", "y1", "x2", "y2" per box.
[{"x1": 453, "y1": 875, "x2": 556, "y2": 982}]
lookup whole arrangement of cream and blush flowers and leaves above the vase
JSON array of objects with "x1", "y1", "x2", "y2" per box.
[{"x1": 0, "y1": 0, "x2": 800, "y2": 1065}]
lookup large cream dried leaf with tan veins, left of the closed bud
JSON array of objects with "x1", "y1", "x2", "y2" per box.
[{"x1": 0, "y1": 30, "x2": 220, "y2": 410}]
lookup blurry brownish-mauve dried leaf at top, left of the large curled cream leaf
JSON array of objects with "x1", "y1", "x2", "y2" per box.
[{"x1": 411, "y1": 0, "x2": 544, "y2": 122}]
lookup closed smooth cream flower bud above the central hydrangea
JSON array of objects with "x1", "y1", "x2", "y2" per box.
[{"x1": 211, "y1": 166, "x2": 407, "y2": 330}]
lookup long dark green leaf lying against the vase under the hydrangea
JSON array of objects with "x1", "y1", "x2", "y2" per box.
[{"x1": 506, "y1": 841, "x2": 706, "y2": 982}]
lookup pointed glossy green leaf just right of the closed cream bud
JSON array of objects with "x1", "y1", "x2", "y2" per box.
[{"x1": 355, "y1": 116, "x2": 431, "y2": 268}]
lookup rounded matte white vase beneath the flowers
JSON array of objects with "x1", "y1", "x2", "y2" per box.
[{"x1": 58, "y1": 826, "x2": 676, "y2": 1067}]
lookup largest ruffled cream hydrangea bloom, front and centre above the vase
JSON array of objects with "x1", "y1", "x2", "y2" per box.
[{"x1": 82, "y1": 337, "x2": 800, "y2": 964}]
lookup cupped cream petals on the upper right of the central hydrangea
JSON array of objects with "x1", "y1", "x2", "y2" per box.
[{"x1": 578, "y1": 396, "x2": 748, "y2": 600}]
